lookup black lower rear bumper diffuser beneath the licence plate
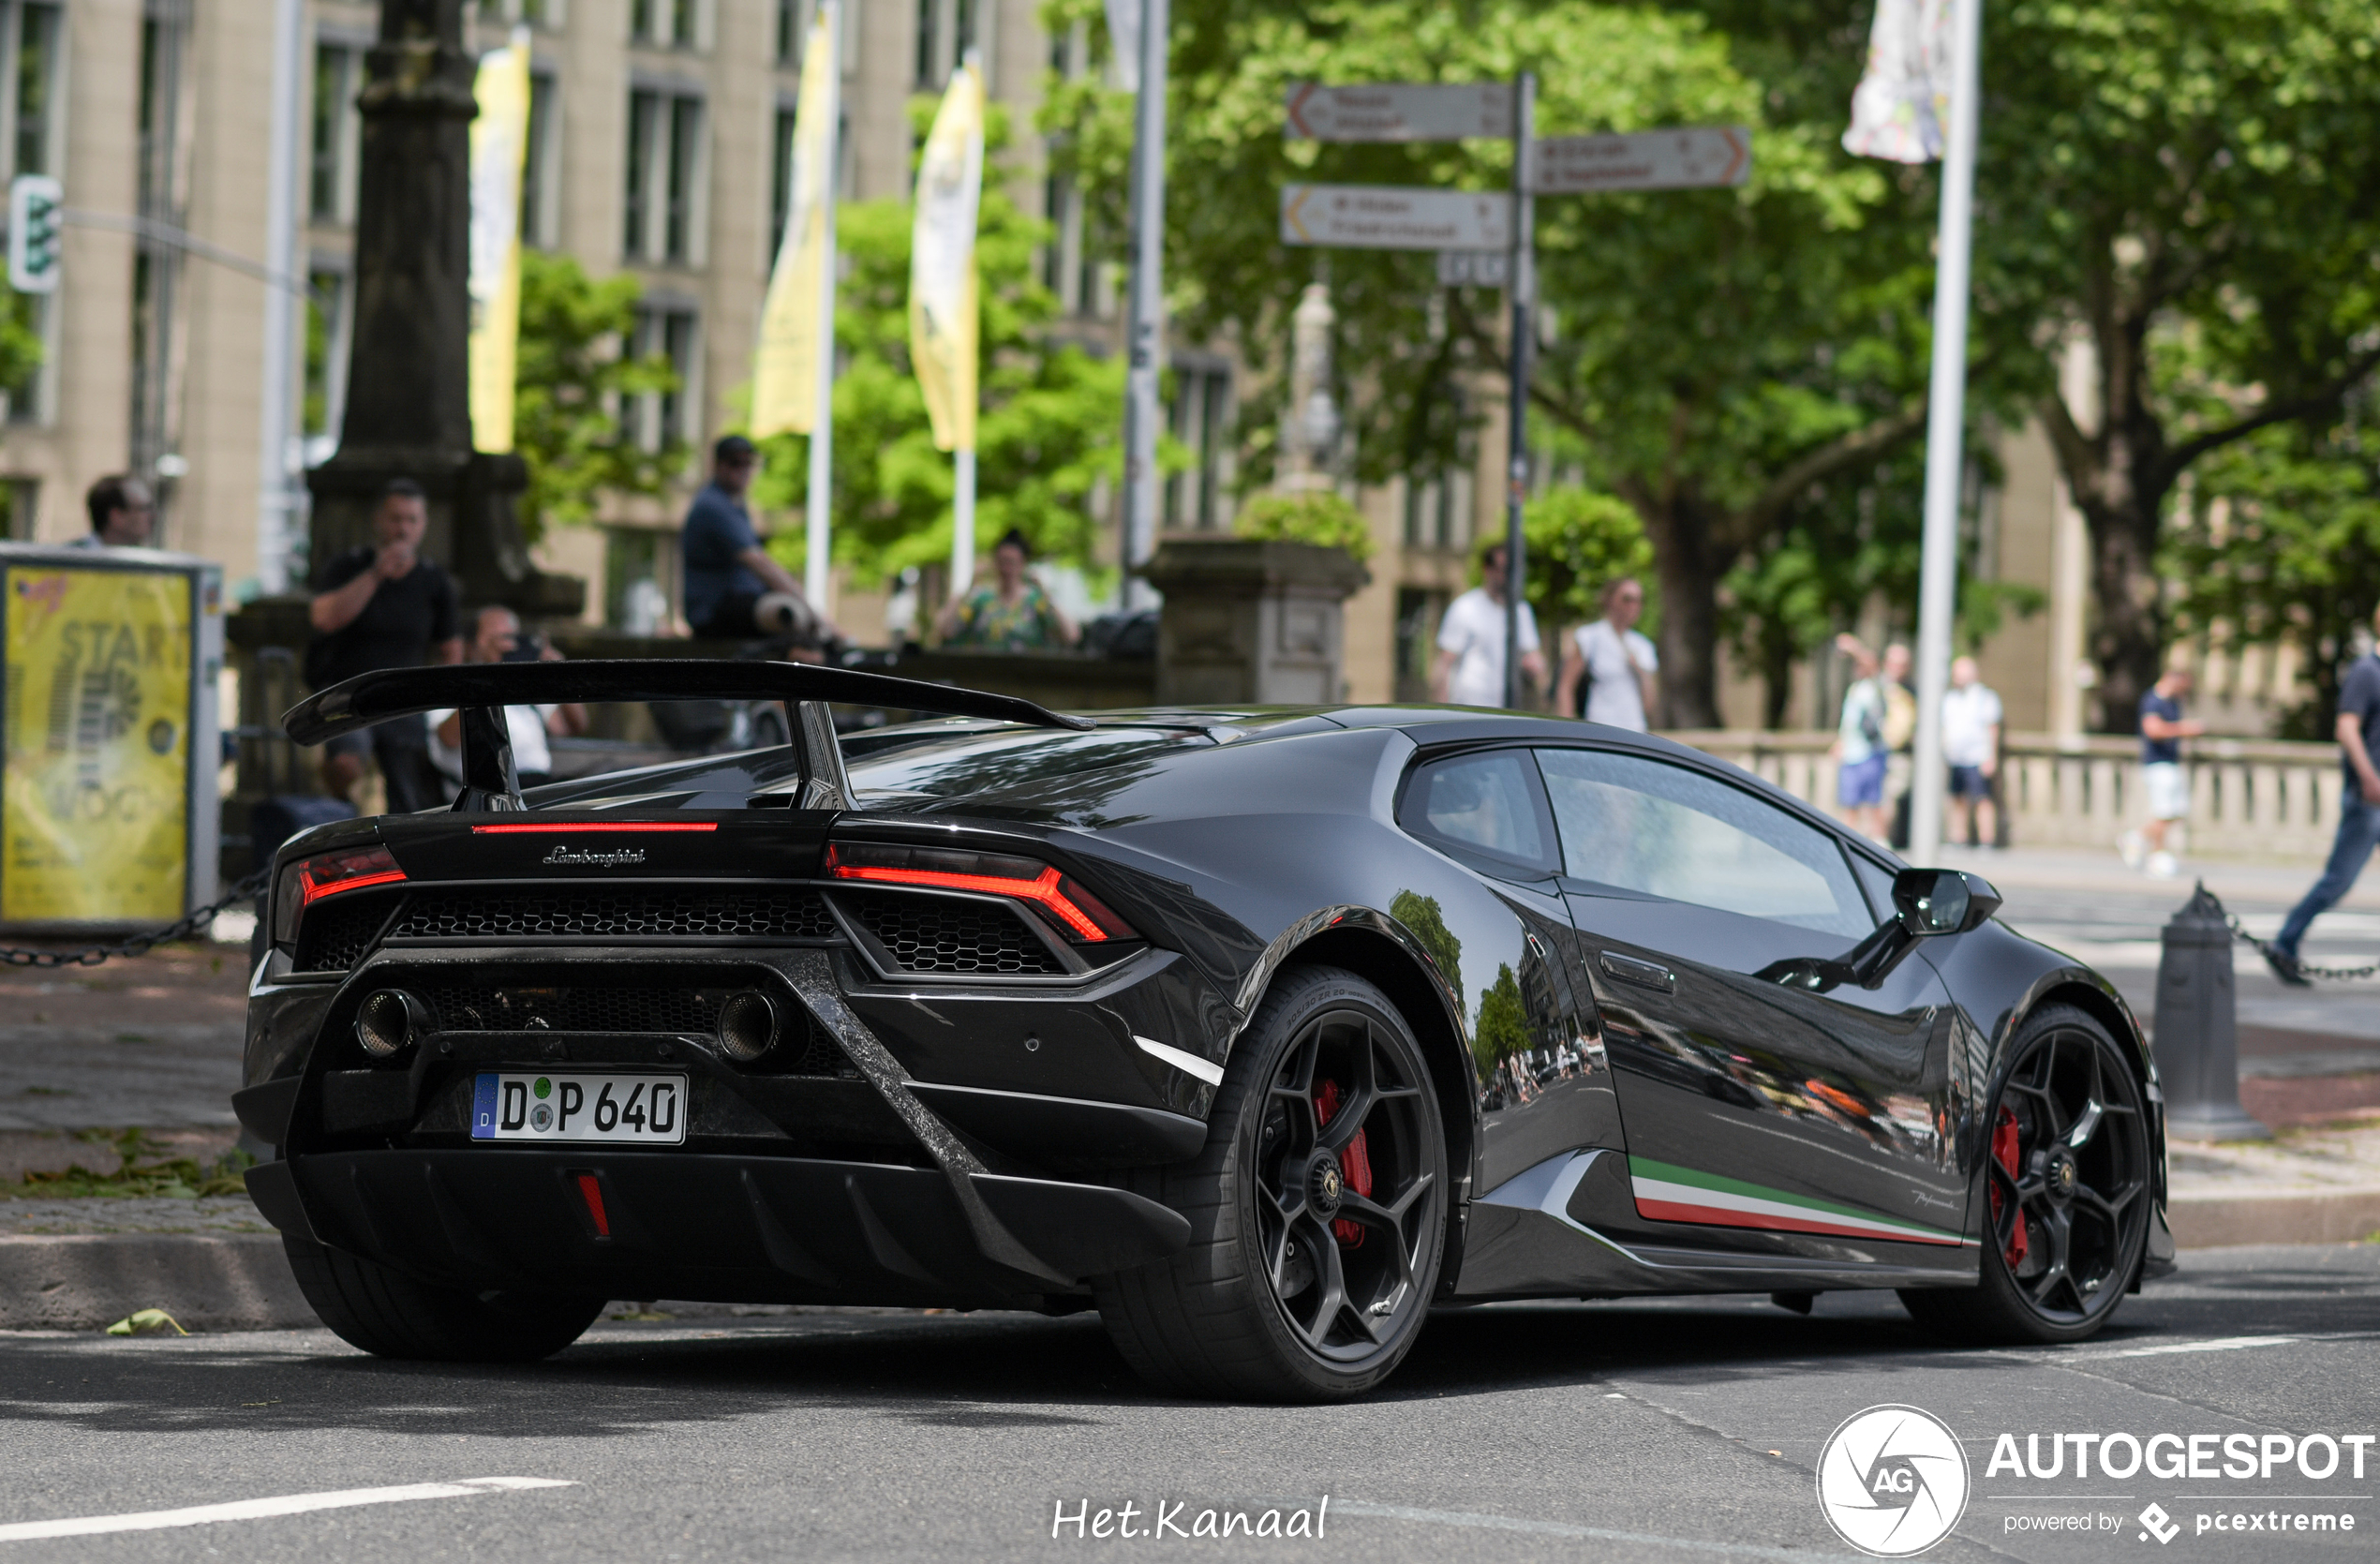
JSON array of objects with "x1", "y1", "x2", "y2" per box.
[{"x1": 247, "y1": 1147, "x2": 1190, "y2": 1307}]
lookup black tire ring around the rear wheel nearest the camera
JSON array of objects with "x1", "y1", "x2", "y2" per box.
[{"x1": 1216, "y1": 969, "x2": 1447, "y2": 1397}]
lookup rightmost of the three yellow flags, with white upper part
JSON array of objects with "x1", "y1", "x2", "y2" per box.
[{"x1": 909, "y1": 65, "x2": 983, "y2": 450}]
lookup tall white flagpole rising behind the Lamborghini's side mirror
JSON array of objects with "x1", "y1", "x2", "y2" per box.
[{"x1": 1909, "y1": 0, "x2": 1983, "y2": 867}]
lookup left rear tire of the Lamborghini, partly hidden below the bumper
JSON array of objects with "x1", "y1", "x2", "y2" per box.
[{"x1": 281, "y1": 1233, "x2": 604, "y2": 1364}]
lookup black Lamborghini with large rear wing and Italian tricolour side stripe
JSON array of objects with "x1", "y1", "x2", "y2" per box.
[{"x1": 235, "y1": 662, "x2": 2173, "y2": 1400}]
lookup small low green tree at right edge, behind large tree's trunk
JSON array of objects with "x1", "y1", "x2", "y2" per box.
[{"x1": 2164, "y1": 409, "x2": 2380, "y2": 738}]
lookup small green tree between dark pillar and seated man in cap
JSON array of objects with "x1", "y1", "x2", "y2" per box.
[{"x1": 512, "y1": 250, "x2": 686, "y2": 541}]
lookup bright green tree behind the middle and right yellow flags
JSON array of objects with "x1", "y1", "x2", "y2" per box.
[{"x1": 754, "y1": 97, "x2": 1123, "y2": 578}]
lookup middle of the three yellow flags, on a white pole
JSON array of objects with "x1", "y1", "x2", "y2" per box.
[{"x1": 752, "y1": 3, "x2": 842, "y2": 438}]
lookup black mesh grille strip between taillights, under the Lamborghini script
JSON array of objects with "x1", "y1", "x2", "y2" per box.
[{"x1": 388, "y1": 886, "x2": 836, "y2": 940}]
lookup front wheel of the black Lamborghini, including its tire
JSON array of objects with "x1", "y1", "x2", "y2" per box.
[{"x1": 1901, "y1": 1005, "x2": 2154, "y2": 1343}]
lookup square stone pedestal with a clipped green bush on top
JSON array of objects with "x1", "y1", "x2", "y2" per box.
[{"x1": 1147, "y1": 538, "x2": 1371, "y2": 705}]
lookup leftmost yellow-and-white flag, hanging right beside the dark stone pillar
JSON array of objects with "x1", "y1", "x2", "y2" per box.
[{"x1": 469, "y1": 26, "x2": 528, "y2": 450}]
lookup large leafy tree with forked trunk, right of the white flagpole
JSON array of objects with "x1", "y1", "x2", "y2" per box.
[{"x1": 1960, "y1": 0, "x2": 2380, "y2": 731}]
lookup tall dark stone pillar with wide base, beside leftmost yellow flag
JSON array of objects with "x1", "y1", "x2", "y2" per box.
[{"x1": 307, "y1": 0, "x2": 586, "y2": 617}]
